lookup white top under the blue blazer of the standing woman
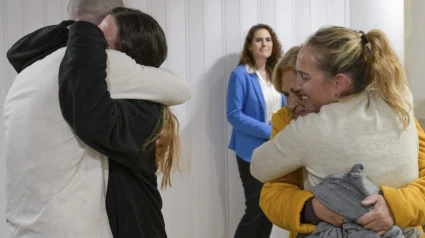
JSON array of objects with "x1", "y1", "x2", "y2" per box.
[{"x1": 256, "y1": 70, "x2": 282, "y2": 124}]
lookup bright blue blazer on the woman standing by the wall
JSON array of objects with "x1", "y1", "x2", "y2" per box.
[{"x1": 227, "y1": 65, "x2": 286, "y2": 162}]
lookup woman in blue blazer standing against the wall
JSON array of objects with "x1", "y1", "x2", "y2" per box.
[{"x1": 227, "y1": 24, "x2": 286, "y2": 238}]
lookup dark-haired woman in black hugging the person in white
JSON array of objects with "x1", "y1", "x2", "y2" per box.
[{"x1": 59, "y1": 8, "x2": 180, "y2": 238}]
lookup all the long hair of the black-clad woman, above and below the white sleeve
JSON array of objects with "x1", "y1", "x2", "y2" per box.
[{"x1": 108, "y1": 7, "x2": 180, "y2": 189}]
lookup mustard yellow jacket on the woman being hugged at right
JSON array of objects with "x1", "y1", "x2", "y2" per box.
[{"x1": 260, "y1": 107, "x2": 425, "y2": 238}]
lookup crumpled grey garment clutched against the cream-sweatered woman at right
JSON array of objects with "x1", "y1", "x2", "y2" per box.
[{"x1": 297, "y1": 164, "x2": 421, "y2": 238}]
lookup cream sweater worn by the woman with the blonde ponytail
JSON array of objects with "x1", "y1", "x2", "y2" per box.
[{"x1": 251, "y1": 88, "x2": 419, "y2": 189}]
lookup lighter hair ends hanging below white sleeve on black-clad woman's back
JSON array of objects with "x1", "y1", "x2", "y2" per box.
[{"x1": 144, "y1": 106, "x2": 181, "y2": 189}]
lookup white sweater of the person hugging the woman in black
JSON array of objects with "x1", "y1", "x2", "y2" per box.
[{"x1": 4, "y1": 48, "x2": 190, "y2": 238}]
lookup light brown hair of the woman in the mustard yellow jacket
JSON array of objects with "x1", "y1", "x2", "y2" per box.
[{"x1": 272, "y1": 46, "x2": 301, "y2": 93}]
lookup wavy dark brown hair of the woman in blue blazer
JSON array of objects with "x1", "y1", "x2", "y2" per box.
[{"x1": 238, "y1": 24, "x2": 282, "y2": 76}]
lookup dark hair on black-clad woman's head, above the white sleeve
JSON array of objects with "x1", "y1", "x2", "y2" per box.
[{"x1": 108, "y1": 7, "x2": 168, "y2": 68}]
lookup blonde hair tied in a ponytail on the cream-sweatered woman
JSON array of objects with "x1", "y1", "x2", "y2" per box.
[{"x1": 306, "y1": 26, "x2": 412, "y2": 128}]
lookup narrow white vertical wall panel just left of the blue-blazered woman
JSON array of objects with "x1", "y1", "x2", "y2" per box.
[{"x1": 202, "y1": 0, "x2": 227, "y2": 238}]
